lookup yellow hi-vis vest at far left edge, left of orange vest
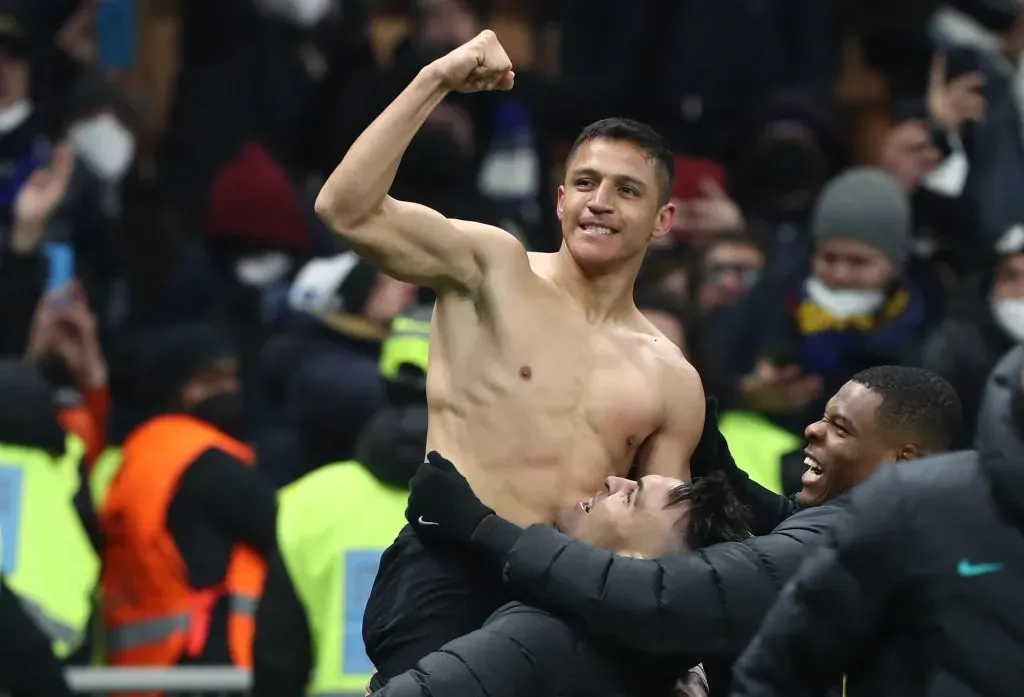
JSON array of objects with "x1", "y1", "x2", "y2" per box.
[{"x1": 0, "y1": 436, "x2": 99, "y2": 658}]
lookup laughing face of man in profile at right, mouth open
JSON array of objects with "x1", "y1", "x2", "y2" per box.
[{"x1": 797, "y1": 381, "x2": 918, "y2": 508}]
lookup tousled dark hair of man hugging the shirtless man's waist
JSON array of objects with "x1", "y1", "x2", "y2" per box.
[{"x1": 665, "y1": 472, "x2": 752, "y2": 550}]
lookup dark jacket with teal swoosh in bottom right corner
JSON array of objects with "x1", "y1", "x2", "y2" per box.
[{"x1": 733, "y1": 451, "x2": 1024, "y2": 697}]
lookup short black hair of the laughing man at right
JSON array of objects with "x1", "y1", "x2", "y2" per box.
[{"x1": 851, "y1": 365, "x2": 964, "y2": 452}]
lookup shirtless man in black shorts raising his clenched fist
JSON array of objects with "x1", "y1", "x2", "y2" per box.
[{"x1": 316, "y1": 31, "x2": 705, "y2": 684}]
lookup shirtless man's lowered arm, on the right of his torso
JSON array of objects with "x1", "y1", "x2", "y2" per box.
[{"x1": 637, "y1": 357, "x2": 705, "y2": 481}]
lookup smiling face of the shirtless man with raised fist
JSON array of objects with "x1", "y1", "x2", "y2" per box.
[{"x1": 558, "y1": 137, "x2": 674, "y2": 271}]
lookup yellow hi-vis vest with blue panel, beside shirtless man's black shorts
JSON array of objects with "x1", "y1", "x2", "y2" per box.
[{"x1": 278, "y1": 461, "x2": 409, "y2": 697}]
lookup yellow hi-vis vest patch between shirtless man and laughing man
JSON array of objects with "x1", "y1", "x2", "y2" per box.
[{"x1": 718, "y1": 411, "x2": 804, "y2": 493}]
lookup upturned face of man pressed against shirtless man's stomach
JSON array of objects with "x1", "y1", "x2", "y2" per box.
[{"x1": 555, "y1": 475, "x2": 690, "y2": 559}]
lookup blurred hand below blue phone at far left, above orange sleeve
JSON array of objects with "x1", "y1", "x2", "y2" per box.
[{"x1": 27, "y1": 279, "x2": 108, "y2": 392}]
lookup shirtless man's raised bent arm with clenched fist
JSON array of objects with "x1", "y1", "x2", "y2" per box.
[{"x1": 315, "y1": 32, "x2": 525, "y2": 294}]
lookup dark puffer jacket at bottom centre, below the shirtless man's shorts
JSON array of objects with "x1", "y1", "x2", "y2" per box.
[{"x1": 374, "y1": 603, "x2": 685, "y2": 697}]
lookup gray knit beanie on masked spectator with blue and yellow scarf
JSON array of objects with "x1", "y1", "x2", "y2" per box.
[{"x1": 811, "y1": 167, "x2": 910, "y2": 265}]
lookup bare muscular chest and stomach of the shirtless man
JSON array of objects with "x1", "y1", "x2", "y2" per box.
[{"x1": 427, "y1": 247, "x2": 703, "y2": 525}]
